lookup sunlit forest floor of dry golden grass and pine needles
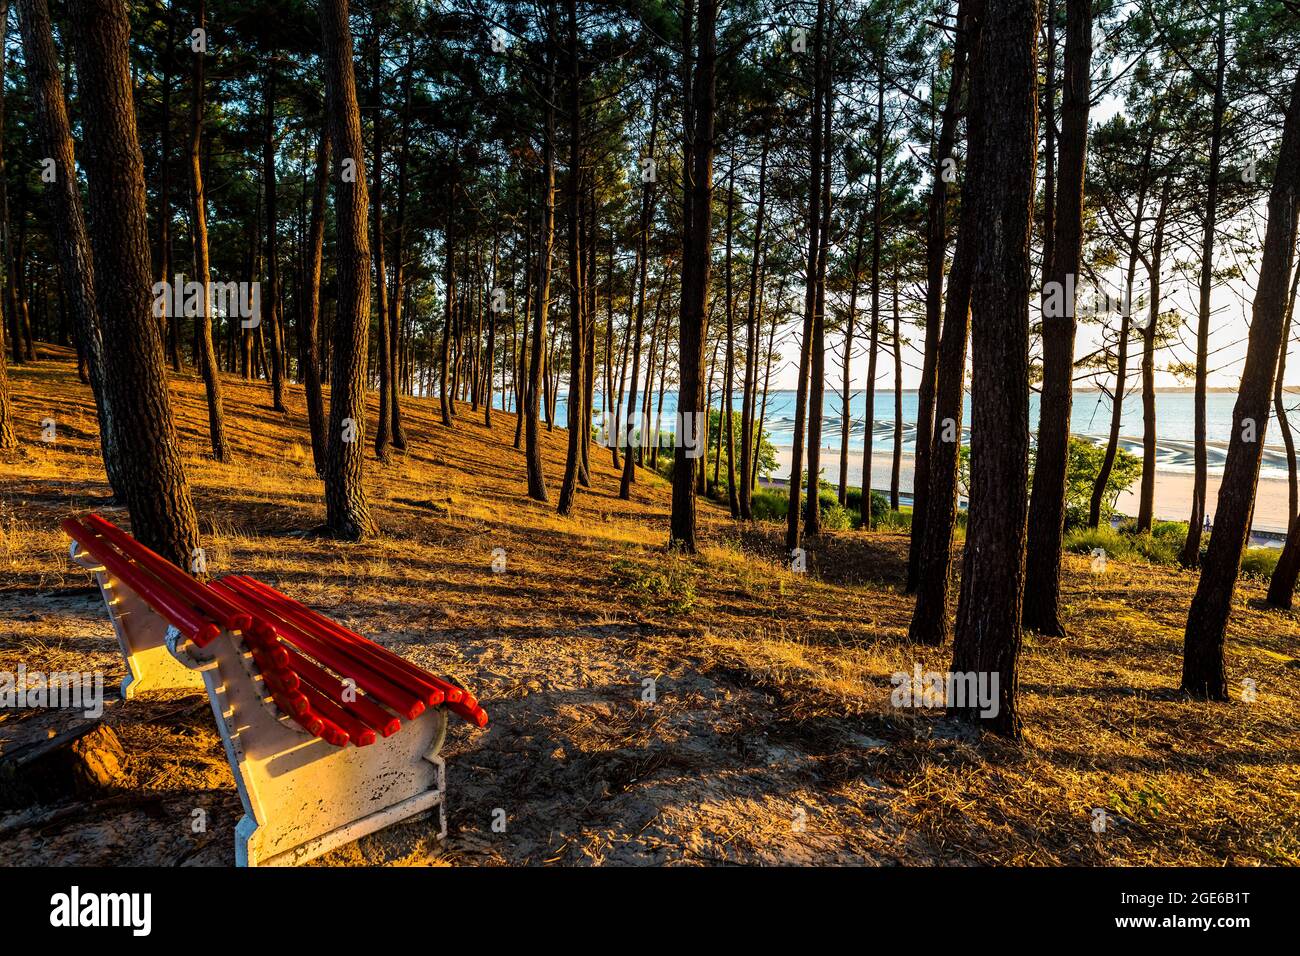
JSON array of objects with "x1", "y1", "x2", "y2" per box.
[{"x1": 0, "y1": 347, "x2": 1300, "y2": 865}]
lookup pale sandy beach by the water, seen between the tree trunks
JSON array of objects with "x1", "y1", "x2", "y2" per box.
[{"x1": 772, "y1": 444, "x2": 1288, "y2": 535}]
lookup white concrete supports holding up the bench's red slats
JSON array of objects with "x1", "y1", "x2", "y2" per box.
[{"x1": 72, "y1": 542, "x2": 457, "y2": 866}]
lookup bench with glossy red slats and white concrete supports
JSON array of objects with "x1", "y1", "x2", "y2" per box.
[{"x1": 62, "y1": 514, "x2": 488, "y2": 866}]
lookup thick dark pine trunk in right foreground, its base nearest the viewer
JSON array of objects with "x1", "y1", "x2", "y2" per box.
[{"x1": 949, "y1": 0, "x2": 1039, "y2": 737}]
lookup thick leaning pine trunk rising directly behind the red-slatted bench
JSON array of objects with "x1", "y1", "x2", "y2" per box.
[{"x1": 69, "y1": 0, "x2": 199, "y2": 568}]
